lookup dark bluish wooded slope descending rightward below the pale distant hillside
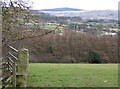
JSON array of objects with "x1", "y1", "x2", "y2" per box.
[{"x1": 31, "y1": 10, "x2": 82, "y2": 24}]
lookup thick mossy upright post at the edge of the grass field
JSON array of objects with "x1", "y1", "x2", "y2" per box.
[{"x1": 16, "y1": 48, "x2": 29, "y2": 87}]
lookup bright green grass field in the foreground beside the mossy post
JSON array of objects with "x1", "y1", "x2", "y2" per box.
[{"x1": 28, "y1": 63, "x2": 118, "y2": 87}]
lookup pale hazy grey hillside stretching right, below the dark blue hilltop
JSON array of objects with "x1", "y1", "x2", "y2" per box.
[{"x1": 42, "y1": 10, "x2": 118, "y2": 20}]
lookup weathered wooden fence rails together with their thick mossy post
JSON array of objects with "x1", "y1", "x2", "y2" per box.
[{"x1": 0, "y1": 45, "x2": 29, "y2": 89}]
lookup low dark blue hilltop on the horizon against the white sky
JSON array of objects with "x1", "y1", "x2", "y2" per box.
[{"x1": 40, "y1": 7, "x2": 83, "y2": 12}]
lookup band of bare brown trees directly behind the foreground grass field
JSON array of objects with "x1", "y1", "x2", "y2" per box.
[{"x1": 14, "y1": 30, "x2": 118, "y2": 63}]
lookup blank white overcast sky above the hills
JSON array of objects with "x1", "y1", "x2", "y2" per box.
[{"x1": 30, "y1": 0, "x2": 120, "y2": 10}]
